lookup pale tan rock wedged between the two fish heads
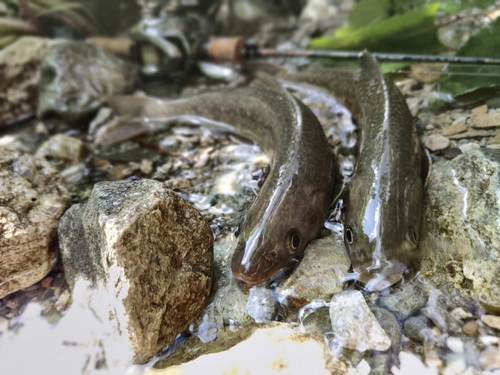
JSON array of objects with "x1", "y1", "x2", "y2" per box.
[{"x1": 277, "y1": 235, "x2": 351, "y2": 307}]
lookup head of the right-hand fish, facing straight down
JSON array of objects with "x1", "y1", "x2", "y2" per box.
[{"x1": 344, "y1": 176, "x2": 423, "y2": 291}]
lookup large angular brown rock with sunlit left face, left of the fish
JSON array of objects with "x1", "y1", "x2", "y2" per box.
[{"x1": 58, "y1": 180, "x2": 213, "y2": 363}]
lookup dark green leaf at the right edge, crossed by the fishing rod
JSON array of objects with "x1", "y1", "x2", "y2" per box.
[{"x1": 439, "y1": 18, "x2": 500, "y2": 97}]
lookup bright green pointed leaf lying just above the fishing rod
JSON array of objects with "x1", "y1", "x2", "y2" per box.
[{"x1": 308, "y1": 4, "x2": 444, "y2": 53}]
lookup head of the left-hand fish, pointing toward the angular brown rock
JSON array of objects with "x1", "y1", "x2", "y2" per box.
[{"x1": 231, "y1": 163, "x2": 333, "y2": 285}]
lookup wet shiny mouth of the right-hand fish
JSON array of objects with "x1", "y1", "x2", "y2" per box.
[{"x1": 356, "y1": 261, "x2": 406, "y2": 292}]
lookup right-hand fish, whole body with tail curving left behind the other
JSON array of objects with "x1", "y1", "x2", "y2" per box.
[{"x1": 277, "y1": 51, "x2": 429, "y2": 291}]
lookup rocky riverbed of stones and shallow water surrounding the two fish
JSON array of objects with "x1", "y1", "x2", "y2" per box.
[{"x1": 0, "y1": 4, "x2": 500, "y2": 375}]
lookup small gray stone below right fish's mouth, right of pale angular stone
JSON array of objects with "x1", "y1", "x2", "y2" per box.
[{"x1": 378, "y1": 278, "x2": 428, "y2": 320}]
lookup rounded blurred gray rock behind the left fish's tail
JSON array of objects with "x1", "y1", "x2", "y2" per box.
[{"x1": 37, "y1": 42, "x2": 137, "y2": 122}]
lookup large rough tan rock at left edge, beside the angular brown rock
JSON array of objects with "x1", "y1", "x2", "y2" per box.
[{"x1": 0, "y1": 147, "x2": 71, "y2": 298}]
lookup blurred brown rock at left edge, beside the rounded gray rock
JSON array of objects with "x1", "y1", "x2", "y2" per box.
[{"x1": 0, "y1": 36, "x2": 58, "y2": 126}]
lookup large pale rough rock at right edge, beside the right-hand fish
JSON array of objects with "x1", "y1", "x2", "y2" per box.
[{"x1": 420, "y1": 149, "x2": 500, "y2": 312}]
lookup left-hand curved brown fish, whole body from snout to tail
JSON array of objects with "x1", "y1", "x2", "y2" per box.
[{"x1": 107, "y1": 79, "x2": 336, "y2": 288}]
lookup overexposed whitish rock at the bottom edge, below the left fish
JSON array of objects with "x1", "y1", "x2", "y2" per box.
[{"x1": 146, "y1": 323, "x2": 352, "y2": 375}]
